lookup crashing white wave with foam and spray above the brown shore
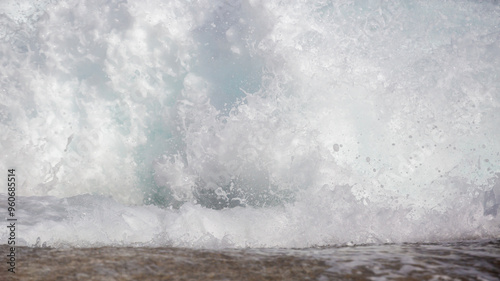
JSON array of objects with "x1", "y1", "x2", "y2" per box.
[{"x1": 0, "y1": 0, "x2": 500, "y2": 247}]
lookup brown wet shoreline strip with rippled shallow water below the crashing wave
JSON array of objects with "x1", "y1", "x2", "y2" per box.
[{"x1": 0, "y1": 240, "x2": 500, "y2": 280}]
